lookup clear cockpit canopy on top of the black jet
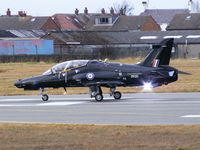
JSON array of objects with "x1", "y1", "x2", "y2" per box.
[{"x1": 43, "y1": 60, "x2": 88, "y2": 75}]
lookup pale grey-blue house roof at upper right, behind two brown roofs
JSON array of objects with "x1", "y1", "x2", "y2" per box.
[{"x1": 140, "y1": 9, "x2": 190, "y2": 24}]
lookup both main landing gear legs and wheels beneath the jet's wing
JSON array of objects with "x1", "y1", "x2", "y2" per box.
[{"x1": 90, "y1": 86, "x2": 122, "y2": 102}]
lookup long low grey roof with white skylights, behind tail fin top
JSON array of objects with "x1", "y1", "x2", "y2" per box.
[{"x1": 46, "y1": 30, "x2": 200, "y2": 45}]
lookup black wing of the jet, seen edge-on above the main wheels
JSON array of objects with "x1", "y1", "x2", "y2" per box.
[{"x1": 84, "y1": 81, "x2": 124, "y2": 87}]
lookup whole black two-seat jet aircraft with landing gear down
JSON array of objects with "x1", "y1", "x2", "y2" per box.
[{"x1": 14, "y1": 39, "x2": 186, "y2": 101}]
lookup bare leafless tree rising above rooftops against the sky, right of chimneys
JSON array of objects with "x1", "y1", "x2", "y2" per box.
[{"x1": 113, "y1": 0, "x2": 134, "y2": 15}]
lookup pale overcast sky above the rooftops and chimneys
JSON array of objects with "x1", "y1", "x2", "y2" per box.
[{"x1": 0, "y1": 0, "x2": 197, "y2": 16}]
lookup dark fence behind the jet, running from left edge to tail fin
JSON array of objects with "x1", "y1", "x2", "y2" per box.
[{"x1": 0, "y1": 45, "x2": 150, "y2": 63}]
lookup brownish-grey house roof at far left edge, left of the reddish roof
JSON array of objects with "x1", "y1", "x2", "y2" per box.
[{"x1": 0, "y1": 16, "x2": 50, "y2": 30}]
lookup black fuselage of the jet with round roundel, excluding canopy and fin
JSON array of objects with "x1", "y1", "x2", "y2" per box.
[{"x1": 15, "y1": 60, "x2": 178, "y2": 90}]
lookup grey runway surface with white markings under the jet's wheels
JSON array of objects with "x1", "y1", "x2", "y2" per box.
[{"x1": 0, "y1": 93, "x2": 200, "y2": 125}]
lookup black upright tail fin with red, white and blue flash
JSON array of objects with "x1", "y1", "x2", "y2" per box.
[{"x1": 140, "y1": 39, "x2": 174, "y2": 67}]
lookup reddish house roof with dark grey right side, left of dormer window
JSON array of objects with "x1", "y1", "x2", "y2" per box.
[{"x1": 52, "y1": 14, "x2": 89, "y2": 30}]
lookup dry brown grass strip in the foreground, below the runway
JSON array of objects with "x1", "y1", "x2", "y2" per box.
[{"x1": 0, "y1": 124, "x2": 200, "y2": 150}]
